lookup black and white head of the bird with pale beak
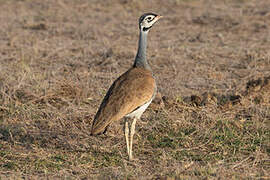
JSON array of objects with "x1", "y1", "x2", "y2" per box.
[{"x1": 139, "y1": 13, "x2": 162, "y2": 32}]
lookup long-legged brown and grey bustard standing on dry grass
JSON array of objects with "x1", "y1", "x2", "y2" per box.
[{"x1": 91, "y1": 13, "x2": 162, "y2": 160}]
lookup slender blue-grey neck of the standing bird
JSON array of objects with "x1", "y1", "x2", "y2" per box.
[{"x1": 133, "y1": 30, "x2": 151, "y2": 71}]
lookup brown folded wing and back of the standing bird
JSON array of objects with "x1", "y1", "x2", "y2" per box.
[{"x1": 91, "y1": 68, "x2": 156, "y2": 135}]
